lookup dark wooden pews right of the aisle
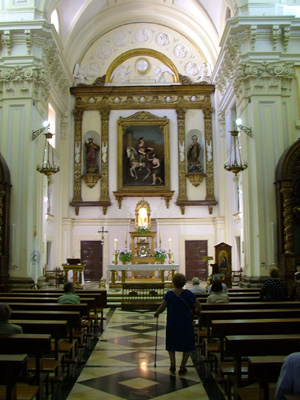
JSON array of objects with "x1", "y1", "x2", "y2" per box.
[{"x1": 195, "y1": 288, "x2": 300, "y2": 400}]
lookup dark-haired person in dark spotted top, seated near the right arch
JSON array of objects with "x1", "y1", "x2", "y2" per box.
[{"x1": 260, "y1": 267, "x2": 288, "y2": 301}]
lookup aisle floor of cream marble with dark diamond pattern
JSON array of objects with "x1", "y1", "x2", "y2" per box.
[{"x1": 67, "y1": 308, "x2": 224, "y2": 400}]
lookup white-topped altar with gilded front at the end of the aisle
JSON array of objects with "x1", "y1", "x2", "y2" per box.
[{"x1": 106, "y1": 264, "x2": 179, "y2": 287}]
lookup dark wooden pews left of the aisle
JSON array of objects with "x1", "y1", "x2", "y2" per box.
[{"x1": 0, "y1": 289, "x2": 107, "y2": 400}]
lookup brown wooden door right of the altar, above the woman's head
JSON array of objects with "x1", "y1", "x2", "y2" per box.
[{"x1": 185, "y1": 240, "x2": 207, "y2": 282}]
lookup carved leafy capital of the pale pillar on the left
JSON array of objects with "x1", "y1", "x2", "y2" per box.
[{"x1": 0, "y1": 66, "x2": 50, "y2": 100}]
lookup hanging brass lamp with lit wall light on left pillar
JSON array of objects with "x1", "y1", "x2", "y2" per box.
[{"x1": 32, "y1": 121, "x2": 59, "y2": 176}]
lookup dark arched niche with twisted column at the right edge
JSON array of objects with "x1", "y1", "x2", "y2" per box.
[{"x1": 275, "y1": 139, "x2": 300, "y2": 279}]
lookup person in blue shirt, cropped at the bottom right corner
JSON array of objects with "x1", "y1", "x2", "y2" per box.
[{"x1": 275, "y1": 352, "x2": 300, "y2": 400}]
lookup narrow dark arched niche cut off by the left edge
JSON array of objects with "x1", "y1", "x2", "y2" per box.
[{"x1": 0, "y1": 153, "x2": 11, "y2": 289}]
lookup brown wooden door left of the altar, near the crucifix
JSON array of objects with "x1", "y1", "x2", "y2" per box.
[{"x1": 81, "y1": 240, "x2": 103, "y2": 282}]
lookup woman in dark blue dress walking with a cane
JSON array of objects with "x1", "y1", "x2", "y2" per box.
[{"x1": 154, "y1": 273, "x2": 201, "y2": 374}]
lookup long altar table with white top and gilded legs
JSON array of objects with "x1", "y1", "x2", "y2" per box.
[{"x1": 106, "y1": 264, "x2": 179, "y2": 285}]
